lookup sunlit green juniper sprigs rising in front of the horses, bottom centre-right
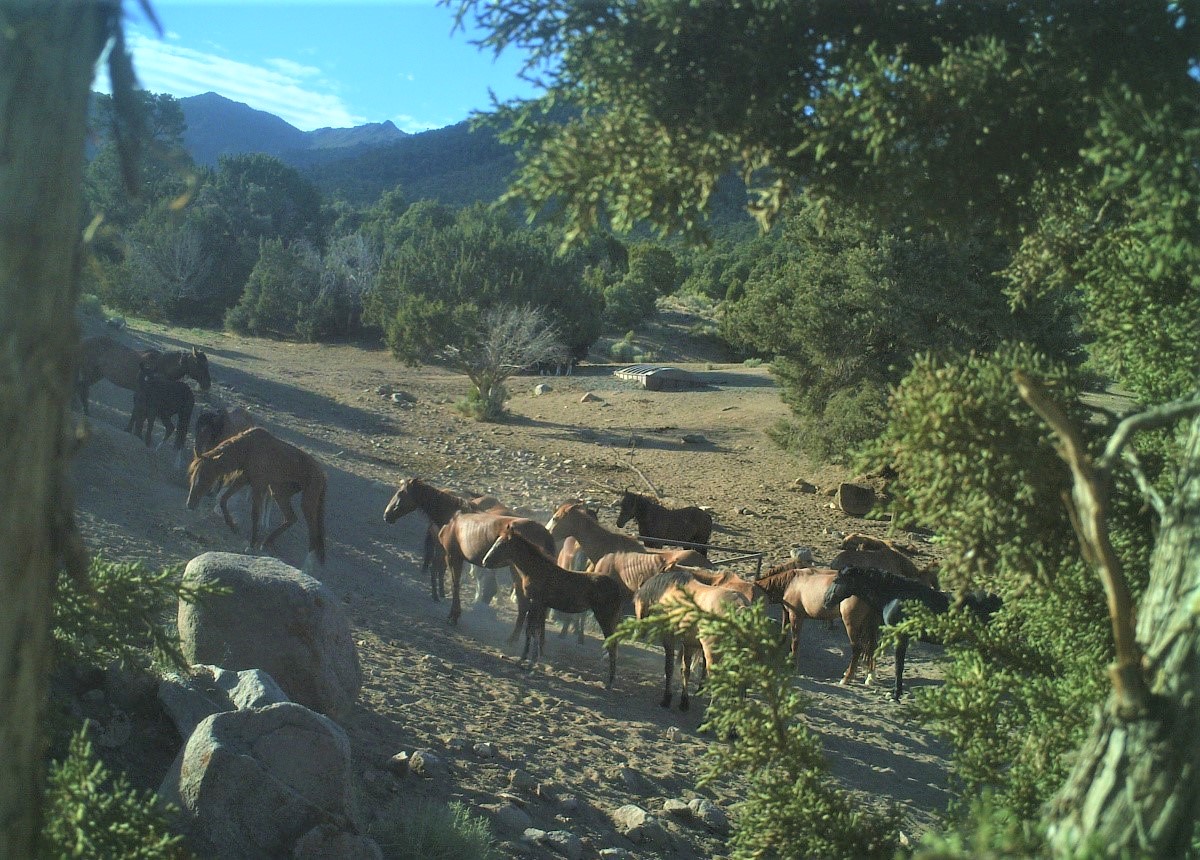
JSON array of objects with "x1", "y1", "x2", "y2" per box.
[{"x1": 611, "y1": 602, "x2": 899, "y2": 860}]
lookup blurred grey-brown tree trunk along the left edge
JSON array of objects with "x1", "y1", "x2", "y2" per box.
[{"x1": 0, "y1": 0, "x2": 116, "y2": 859}]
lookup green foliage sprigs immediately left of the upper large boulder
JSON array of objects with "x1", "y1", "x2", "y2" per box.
[{"x1": 53, "y1": 558, "x2": 225, "y2": 667}]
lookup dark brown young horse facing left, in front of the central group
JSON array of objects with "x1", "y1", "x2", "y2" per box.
[{"x1": 482, "y1": 515, "x2": 622, "y2": 688}]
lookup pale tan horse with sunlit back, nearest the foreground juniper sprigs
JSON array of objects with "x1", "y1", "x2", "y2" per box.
[{"x1": 634, "y1": 570, "x2": 750, "y2": 711}]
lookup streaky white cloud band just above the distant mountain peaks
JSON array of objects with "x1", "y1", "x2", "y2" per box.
[{"x1": 124, "y1": 32, "x2": 367, "y2": 131}]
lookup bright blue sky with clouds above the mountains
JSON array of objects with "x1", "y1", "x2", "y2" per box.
[{"x1": 110, "y1": 0, "x2": 535, "y2": 133}]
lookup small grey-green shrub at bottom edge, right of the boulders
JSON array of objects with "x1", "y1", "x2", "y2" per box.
[{"x1": 371, "y1": 801, "x2": 500, "y2": 860}]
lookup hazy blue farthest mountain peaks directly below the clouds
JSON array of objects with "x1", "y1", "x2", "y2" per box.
[{"x1": 179, "y1": 92, "x2": 406, "y2": 167}]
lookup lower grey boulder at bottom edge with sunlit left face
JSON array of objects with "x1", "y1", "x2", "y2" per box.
[{"x1": 158, "y1": 702, "x2": 368, "y2": 858}]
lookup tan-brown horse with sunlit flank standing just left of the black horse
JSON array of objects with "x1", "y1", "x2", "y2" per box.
[{"x1": 755, "y1": 561, "x2": 880, "y2": 685}]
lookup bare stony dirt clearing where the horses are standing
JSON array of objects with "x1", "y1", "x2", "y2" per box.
[{"x1": 74, "y1": 311, "x2": 948, "y2": 858}]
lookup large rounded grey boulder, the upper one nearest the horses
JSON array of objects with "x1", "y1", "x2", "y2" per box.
[{"x1": 179, "y1": 553, "x2": 362, "y2": 720}]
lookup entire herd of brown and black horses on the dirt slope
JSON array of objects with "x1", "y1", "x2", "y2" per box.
[{"x1": 77, "y1": 336, "x2": 1000, "y2": 710}]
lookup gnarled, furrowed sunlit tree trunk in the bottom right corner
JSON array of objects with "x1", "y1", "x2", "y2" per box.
[{"x1": 1050, "y1": 419, "x2": 1200, "y2": 856}]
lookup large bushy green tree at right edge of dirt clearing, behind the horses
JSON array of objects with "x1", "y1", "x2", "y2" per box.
[{"x1": 721, "y1": 205, "x2": 1072, "y2": 457}]
